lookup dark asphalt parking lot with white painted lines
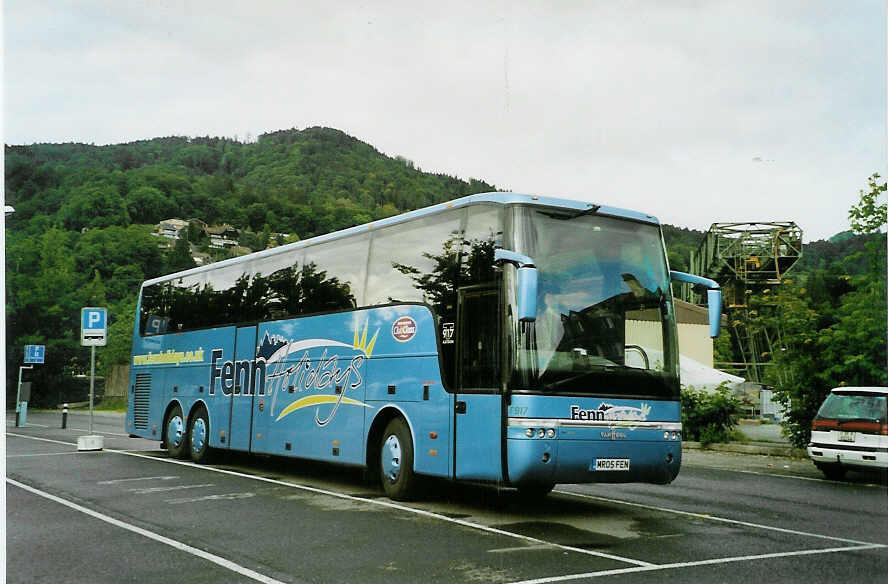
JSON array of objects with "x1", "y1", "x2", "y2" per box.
[{"x1": 6, "y1": 414, "x2": 888, "y2": 583}]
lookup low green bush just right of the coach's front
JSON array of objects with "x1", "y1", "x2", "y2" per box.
[{"x1": 681, "y1": 383, "x2": 740, "y2": 445}]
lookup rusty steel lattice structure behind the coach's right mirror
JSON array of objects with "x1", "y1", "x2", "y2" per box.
[{"x1": 680, "y1": 221, "x2": 802, "y2": 382}]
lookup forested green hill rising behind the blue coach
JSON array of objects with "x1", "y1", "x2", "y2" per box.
[{"x1": 5, "y1": 128, "x2": 865, "y2": 405}]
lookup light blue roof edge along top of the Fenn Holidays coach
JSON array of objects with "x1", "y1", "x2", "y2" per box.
[{"x1": 142, "y1": 192, "x2": 660, "y2": 287}]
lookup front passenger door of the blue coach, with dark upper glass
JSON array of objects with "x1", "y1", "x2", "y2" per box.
[{"x1": 454, "y1": 286, "x2": 503, "y2": 480}]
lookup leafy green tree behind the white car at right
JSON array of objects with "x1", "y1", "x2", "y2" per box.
[{"x1": 761, "y1": 174, "x2": 888, "y2": 447}]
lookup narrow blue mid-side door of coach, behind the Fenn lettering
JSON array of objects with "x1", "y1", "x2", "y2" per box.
[{"x1": 228, "y1": 326, "x2": 264, "y2": 450}]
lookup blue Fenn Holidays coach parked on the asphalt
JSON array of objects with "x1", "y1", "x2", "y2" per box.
[{"x1": 126, "y1": 193, "x2": 721, "y2": 499}]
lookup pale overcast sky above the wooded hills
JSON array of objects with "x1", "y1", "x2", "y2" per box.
[{"x1": 2, "y1": 0, "x2": 888, "y2": 241}]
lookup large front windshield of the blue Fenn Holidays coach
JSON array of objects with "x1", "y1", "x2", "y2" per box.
[{"x1": 513, "y1": 207, "x2": 678, "y2": 399}]
